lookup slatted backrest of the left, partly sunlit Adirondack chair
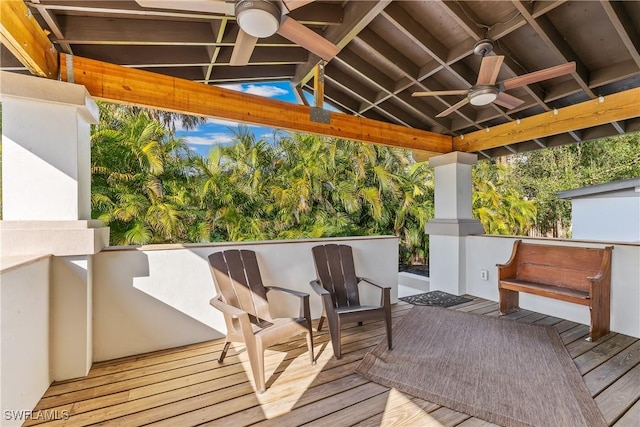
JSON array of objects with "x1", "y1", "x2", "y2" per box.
[{"x1": 209, "y1": 249, "x2": 272, "y2": 320}]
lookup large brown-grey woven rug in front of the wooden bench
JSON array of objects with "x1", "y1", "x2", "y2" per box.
[{"x1": 356, "y1": 306, "x2": 607, "y2": 427}]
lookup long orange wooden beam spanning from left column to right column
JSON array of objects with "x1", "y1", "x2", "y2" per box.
[{"x1": 60, "y1": 54, "x2": 452, "y2": 153}]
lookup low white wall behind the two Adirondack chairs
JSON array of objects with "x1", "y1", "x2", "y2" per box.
[{"x1": 93, "y1": 237, "x2": 398, "y2": 361}]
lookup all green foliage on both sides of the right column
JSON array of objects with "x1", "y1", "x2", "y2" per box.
[{"x1": 91, "y1": 104, "x2": 640, "y2": 263}]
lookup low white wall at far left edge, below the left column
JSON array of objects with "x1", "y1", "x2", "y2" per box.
[{"x1": 0, "y1": 257, "x2": 51, "y2": 426}]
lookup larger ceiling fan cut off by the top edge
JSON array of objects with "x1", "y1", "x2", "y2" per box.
[{"x1": 136, "y1": 0, "x2": 340, "y2": 65}]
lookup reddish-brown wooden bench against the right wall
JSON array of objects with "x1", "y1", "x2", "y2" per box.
[{"x1": 497, "y1": 240, "x2": 613, "y2": 341}]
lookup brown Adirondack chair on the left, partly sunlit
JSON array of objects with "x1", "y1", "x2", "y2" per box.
[{"x1": 209, "y1": 249, "x2": 315, "y2": 393}]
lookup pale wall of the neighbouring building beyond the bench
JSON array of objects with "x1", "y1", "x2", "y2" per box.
[{"x1": 571, "y1": 198, "x2": 640, "y2": 243}]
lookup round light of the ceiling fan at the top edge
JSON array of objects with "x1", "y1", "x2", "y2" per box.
[{"x1": 235, "y1": 0, "x2": 280, "y2": 38}]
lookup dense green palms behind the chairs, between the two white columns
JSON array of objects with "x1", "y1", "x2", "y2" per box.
[{"x1": 91, "y1": 104, "x2": 433, "y2": 262}]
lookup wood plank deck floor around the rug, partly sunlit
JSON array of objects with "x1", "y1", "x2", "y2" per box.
[{"x1": 28, "y1": 298, "x2": 640, "y2": 427}]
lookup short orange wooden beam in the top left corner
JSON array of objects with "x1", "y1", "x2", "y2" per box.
[{"x1": 0, "y1": 0, "x2": 58, "y2": 79}]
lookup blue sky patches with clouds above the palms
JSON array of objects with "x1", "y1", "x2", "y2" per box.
[{"x1": 176, "y1": 81, "x2": 304, "y2": 156}]
